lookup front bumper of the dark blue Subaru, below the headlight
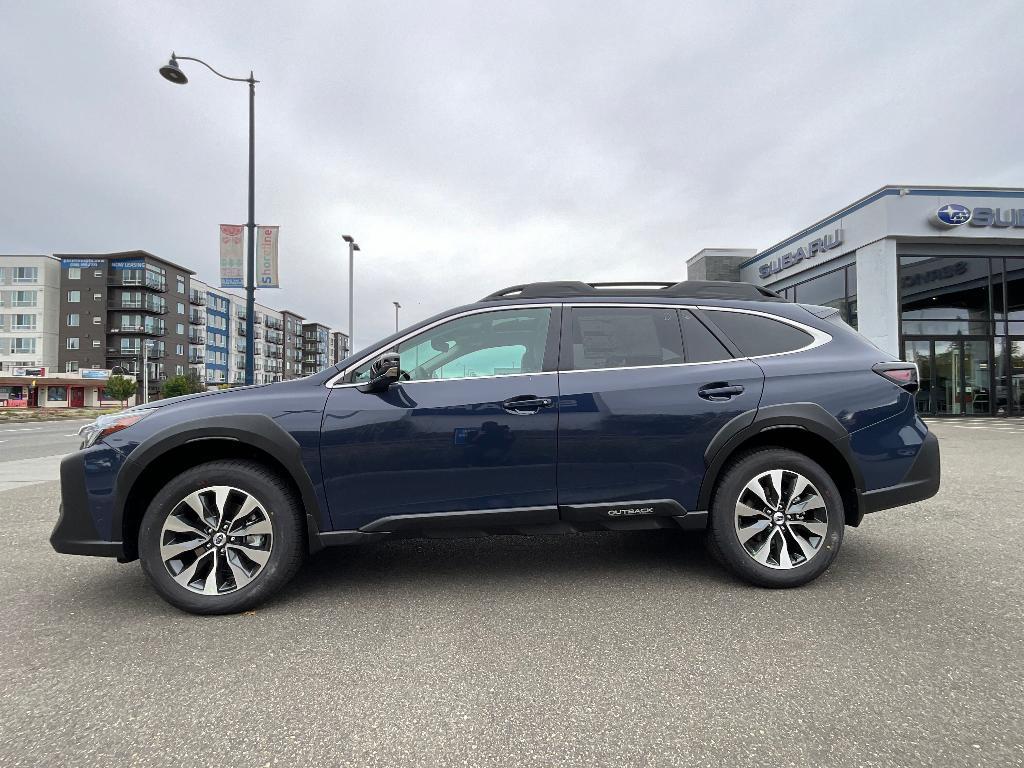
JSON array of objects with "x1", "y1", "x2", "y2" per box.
[{"x1": 50, "y1": 445, "x2": 124, "y2": 559}]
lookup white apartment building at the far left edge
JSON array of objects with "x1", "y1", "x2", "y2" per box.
[{"x1": 0, "y1": 256, "x2": 60, "y2": 374}]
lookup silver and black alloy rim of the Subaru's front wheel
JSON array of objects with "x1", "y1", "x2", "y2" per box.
[{"x1": 160, "y1": 485, "x2": 273, "y2": 595}]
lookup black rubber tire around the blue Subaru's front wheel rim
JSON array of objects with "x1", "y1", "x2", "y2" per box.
[{"x1": 138, "y1": 460, "x2": 305, "y2": 614}]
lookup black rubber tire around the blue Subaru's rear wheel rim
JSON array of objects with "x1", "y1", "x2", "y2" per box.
[{"x1": 708, "y1": 446, "x2": 845, "y2": 589}]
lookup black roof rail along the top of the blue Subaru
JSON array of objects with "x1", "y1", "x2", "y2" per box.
[{"x1": 480, "y1": 280, "x2": 785, "y2": 301}]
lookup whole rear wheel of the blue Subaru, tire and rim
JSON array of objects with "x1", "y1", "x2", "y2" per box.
[{"x1": 709, "y1": 447, "x2": 845, "y2": 588}]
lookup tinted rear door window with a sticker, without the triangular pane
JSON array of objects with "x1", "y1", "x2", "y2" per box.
[{"x1": 563, "y1": 307, "x2": 683, "y2": 371}]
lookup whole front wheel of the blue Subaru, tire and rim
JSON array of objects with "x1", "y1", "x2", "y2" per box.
[{"x1": 138, "y1": 460, "x2": 304, "y2": 613}]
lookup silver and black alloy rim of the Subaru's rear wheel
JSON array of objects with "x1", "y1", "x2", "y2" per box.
[{"x1": 735, "y1": 469, "x2": 828, "y2": 570}]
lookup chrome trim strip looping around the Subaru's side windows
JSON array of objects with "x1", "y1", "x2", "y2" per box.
[{"x1": 327, "y1": 301, "x2": 833, "y2": 389}]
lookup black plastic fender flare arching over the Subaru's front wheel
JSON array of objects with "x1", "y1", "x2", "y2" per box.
[{"x1": 112, "y1": 414, "x2": 323, "y2": 549}]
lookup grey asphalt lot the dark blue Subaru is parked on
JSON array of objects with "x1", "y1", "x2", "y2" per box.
[{"x1": 0, "y1": 420, "x2": 1024, "y2": 767}]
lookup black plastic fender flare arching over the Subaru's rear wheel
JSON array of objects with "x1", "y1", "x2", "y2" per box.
[{"x1": 697, "y1": 402, "x2": 864, "y2": 518}]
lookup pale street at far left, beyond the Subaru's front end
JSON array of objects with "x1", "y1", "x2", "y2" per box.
[{"x1": 0, "y1": 419, "x2": 90, "y2": 493}]
